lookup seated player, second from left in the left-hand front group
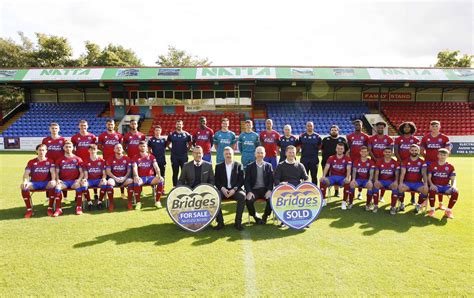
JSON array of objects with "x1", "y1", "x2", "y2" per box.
[{"x1": 53, "y1": 141, "x2": 83, "y2": 217}]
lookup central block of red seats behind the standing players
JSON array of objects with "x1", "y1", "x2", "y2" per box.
[{"x1": 149, "y1": 112, "x2": 240, "y2": 135}]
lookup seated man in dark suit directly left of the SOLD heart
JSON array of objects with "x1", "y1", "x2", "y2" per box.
[{"x1": 245, "y1": 146, "x2": 273, "y2": 224}]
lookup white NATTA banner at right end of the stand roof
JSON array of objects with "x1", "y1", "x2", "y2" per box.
[{"x1": 368, "y1": 68, "x2": 448, "y2": 81}]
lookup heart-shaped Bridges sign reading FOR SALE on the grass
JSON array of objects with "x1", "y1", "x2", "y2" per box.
[{"x1": 166, "y1": 184, "x2": 221, "y2": 232}]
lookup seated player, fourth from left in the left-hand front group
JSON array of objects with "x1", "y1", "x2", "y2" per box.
[{"x1": 105, "y1": 144, "x2": 133, "y2": 212}]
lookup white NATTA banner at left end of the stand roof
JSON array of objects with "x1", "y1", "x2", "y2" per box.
[{"x1": 23, "y1": 68, "x2": 104, "y2": 81}]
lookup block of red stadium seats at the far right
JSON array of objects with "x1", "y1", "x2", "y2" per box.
[{"x1": 382, "y1": 102, "x2": 474, "y2": 136}]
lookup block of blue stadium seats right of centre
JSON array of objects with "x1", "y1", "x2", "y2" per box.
[{"x1": 255, "y1": 102, "x2": 370, "y2": 135}]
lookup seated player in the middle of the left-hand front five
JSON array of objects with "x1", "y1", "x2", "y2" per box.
[{"x1": 81, "y1": 144, "x2": 107, "y2": 211}]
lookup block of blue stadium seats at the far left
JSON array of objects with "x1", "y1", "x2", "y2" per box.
[{"x1": 3, "y1": 102, "x2": 107, "y2": 137}]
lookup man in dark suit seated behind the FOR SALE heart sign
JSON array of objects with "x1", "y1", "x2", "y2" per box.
[{"x1": 178, "y1": 146, "x2": 214, "y2": 188}]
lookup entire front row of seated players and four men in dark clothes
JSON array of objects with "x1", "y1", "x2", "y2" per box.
[{"x1": 21, "y1": 140, "x2": 458, "y2": 230}]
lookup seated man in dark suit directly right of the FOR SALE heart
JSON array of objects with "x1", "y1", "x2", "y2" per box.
[{"x1": 215, "y1": 147, "x2": 245, "y2": 231}]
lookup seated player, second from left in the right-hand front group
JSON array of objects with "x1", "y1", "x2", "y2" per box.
[{"x1": 349, "y1": 146, "x2": 379, "y2": 213}]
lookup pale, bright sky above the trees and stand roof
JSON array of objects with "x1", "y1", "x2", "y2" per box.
[{"x1": 0, "y1": 0, "x2": 474, "y2": 66}]
